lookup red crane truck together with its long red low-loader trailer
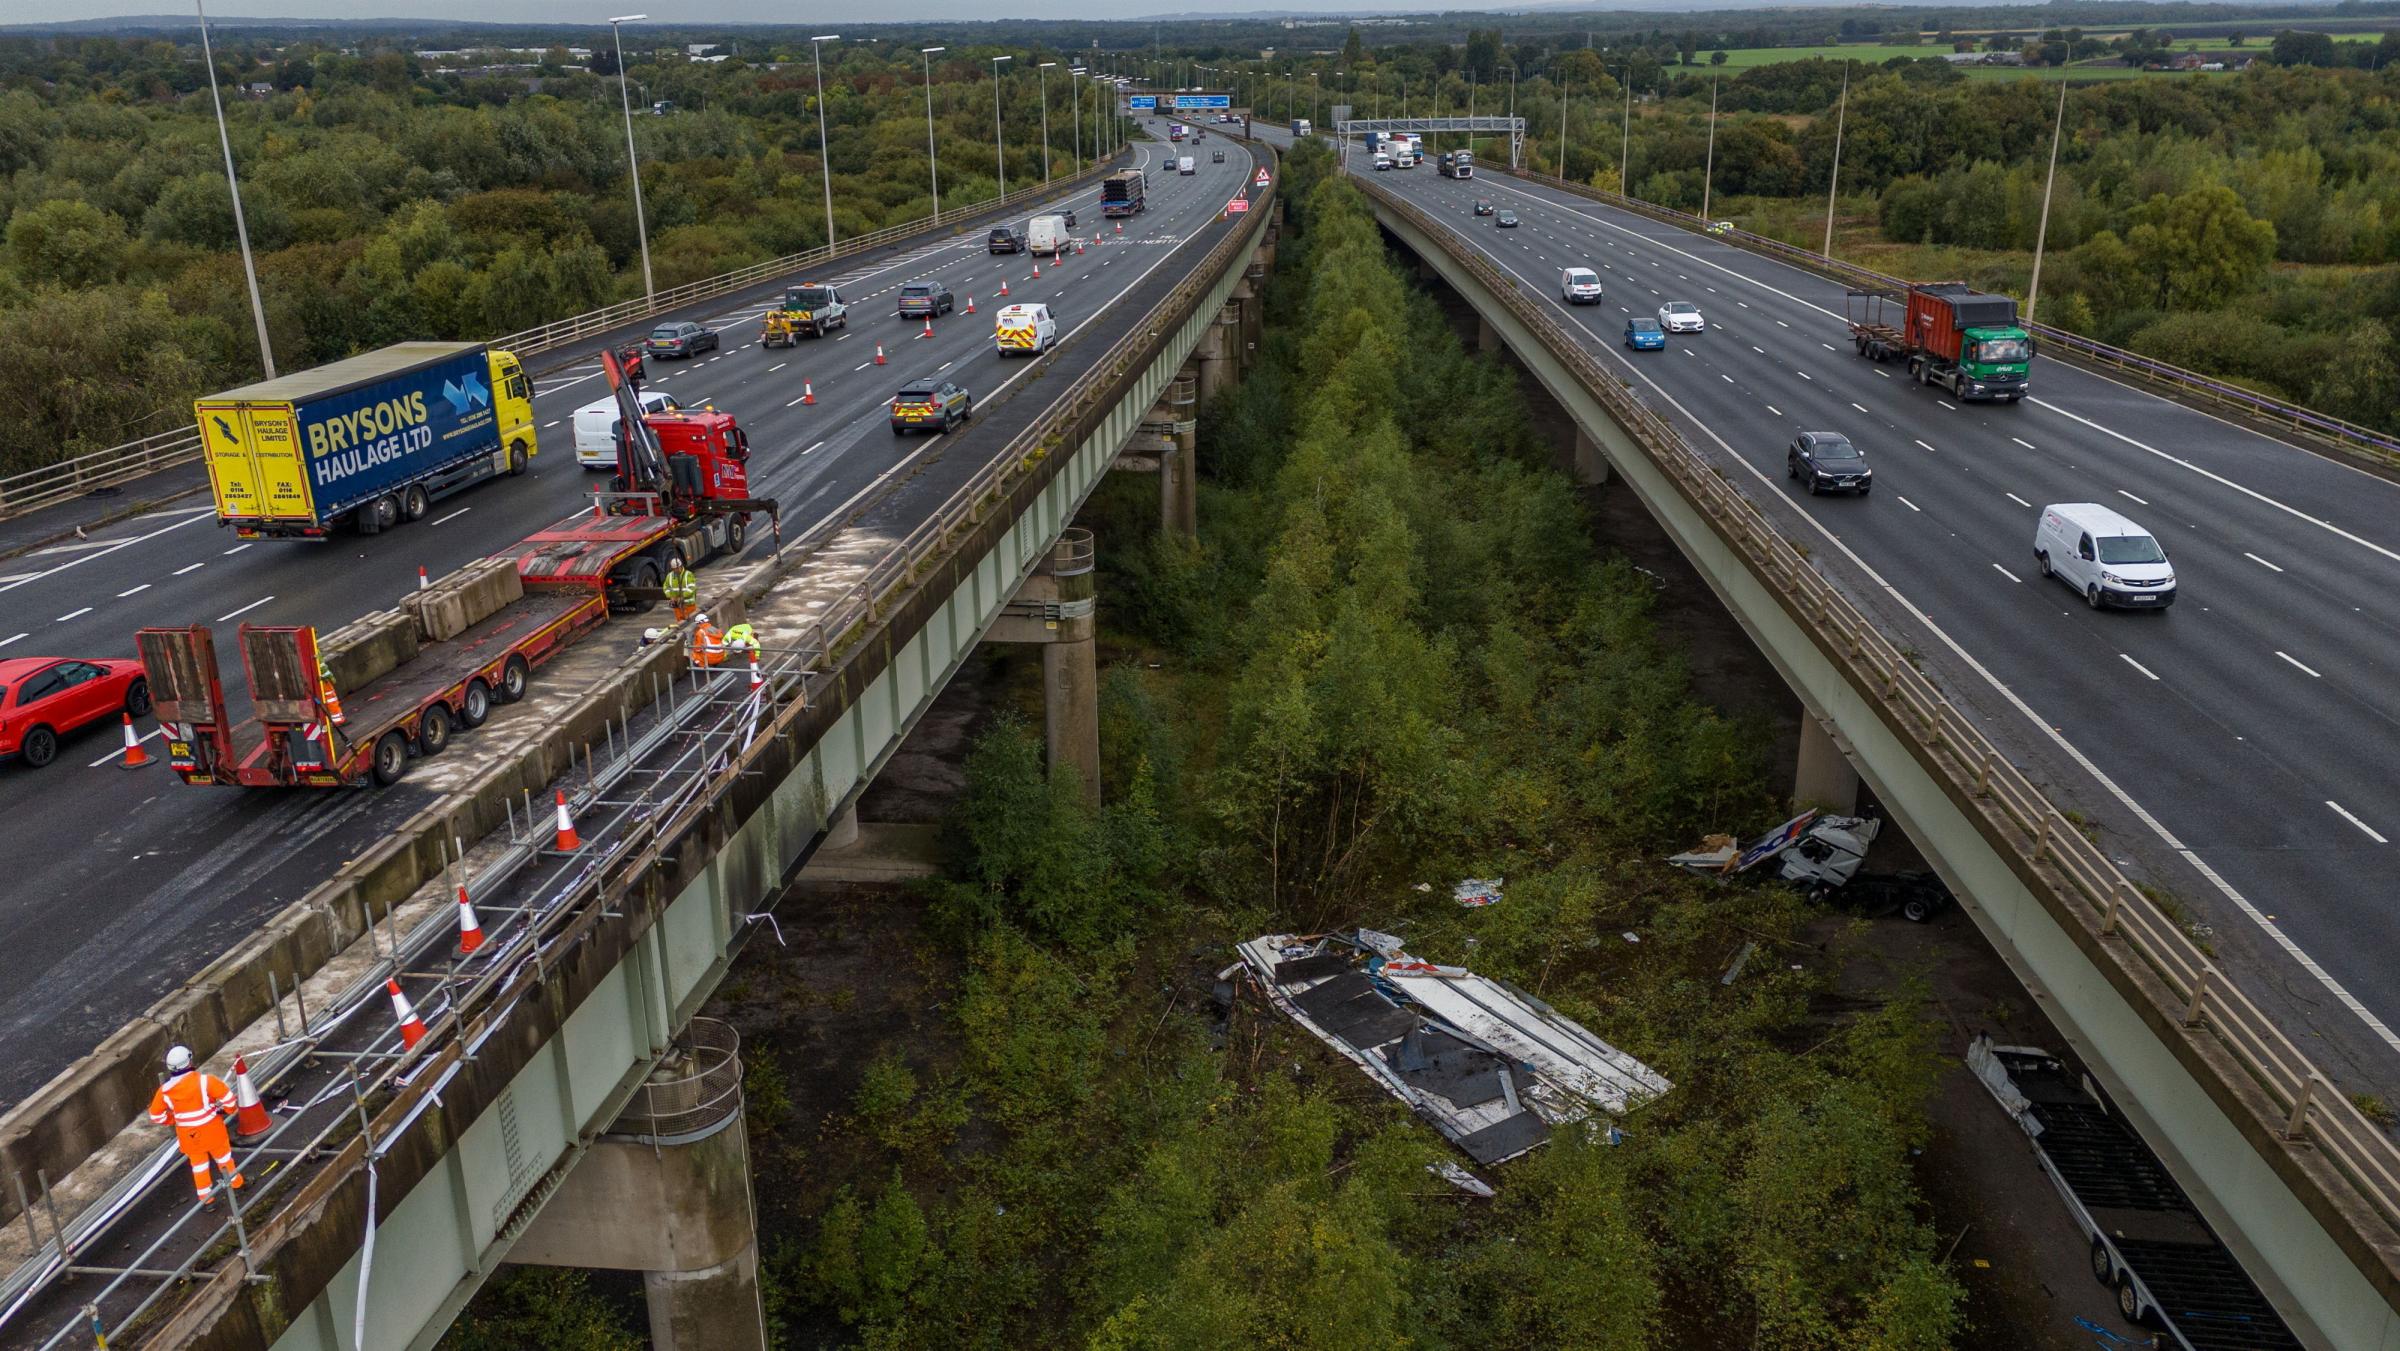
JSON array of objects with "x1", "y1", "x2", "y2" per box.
[{"x1": 134, "y1": 353, "x2": 780, "y2": 787}]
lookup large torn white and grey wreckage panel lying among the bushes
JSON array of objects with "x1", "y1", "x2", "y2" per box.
[{"x1": 1238, "y1": 929, "x2": 1673, "y2": 1164}]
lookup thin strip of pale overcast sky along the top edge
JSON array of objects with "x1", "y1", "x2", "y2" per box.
[{"x1": 28, "y1": 0, "x2": 1471, "y2": 24}]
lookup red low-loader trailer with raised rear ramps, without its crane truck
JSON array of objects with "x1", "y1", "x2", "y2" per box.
[{"x1": 134, "y1": 586, "x2": 607, "y2": 787}]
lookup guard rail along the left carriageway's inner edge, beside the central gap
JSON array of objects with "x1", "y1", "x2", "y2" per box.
[{"x1": 50, "y1": 142, "x2": 1282, "y2": 1344}]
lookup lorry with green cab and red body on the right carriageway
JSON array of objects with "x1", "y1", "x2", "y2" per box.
[{"x1": 1846, "y1": 281, "x2": 2033, "y2": 403}]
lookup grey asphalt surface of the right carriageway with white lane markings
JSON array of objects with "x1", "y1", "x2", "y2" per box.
[{"x1": 1279, "y1": 137, "x2": 2400, "y2": 1101}]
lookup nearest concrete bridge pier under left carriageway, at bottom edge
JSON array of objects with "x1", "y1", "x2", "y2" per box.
[{"x1": 509, "y1": 1017, "x2": 766, "y2": 1351}]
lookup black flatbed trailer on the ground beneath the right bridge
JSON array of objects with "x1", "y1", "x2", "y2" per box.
[{"x1": 1966, "y1": 1037, "x2": 2302, "y2": 1351}]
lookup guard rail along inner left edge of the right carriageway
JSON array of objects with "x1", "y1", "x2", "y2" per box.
[{"x1": 1354, "y1": 180, "x2": 2400, "y2": 1250}]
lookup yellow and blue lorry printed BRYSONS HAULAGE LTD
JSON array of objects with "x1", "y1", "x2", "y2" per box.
[{"x1": 194, "y1": 343, "x2": 535, "y2": 540}]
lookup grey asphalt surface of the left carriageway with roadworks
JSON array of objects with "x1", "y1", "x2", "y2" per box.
[{"x1": 0, "y1": 142, "x2": 1253, "y2": 1101}]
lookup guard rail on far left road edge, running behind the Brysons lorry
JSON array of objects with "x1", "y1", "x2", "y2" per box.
[{"x1": 0, "y1": 158, "x2": 1116, "y2": 518}]
